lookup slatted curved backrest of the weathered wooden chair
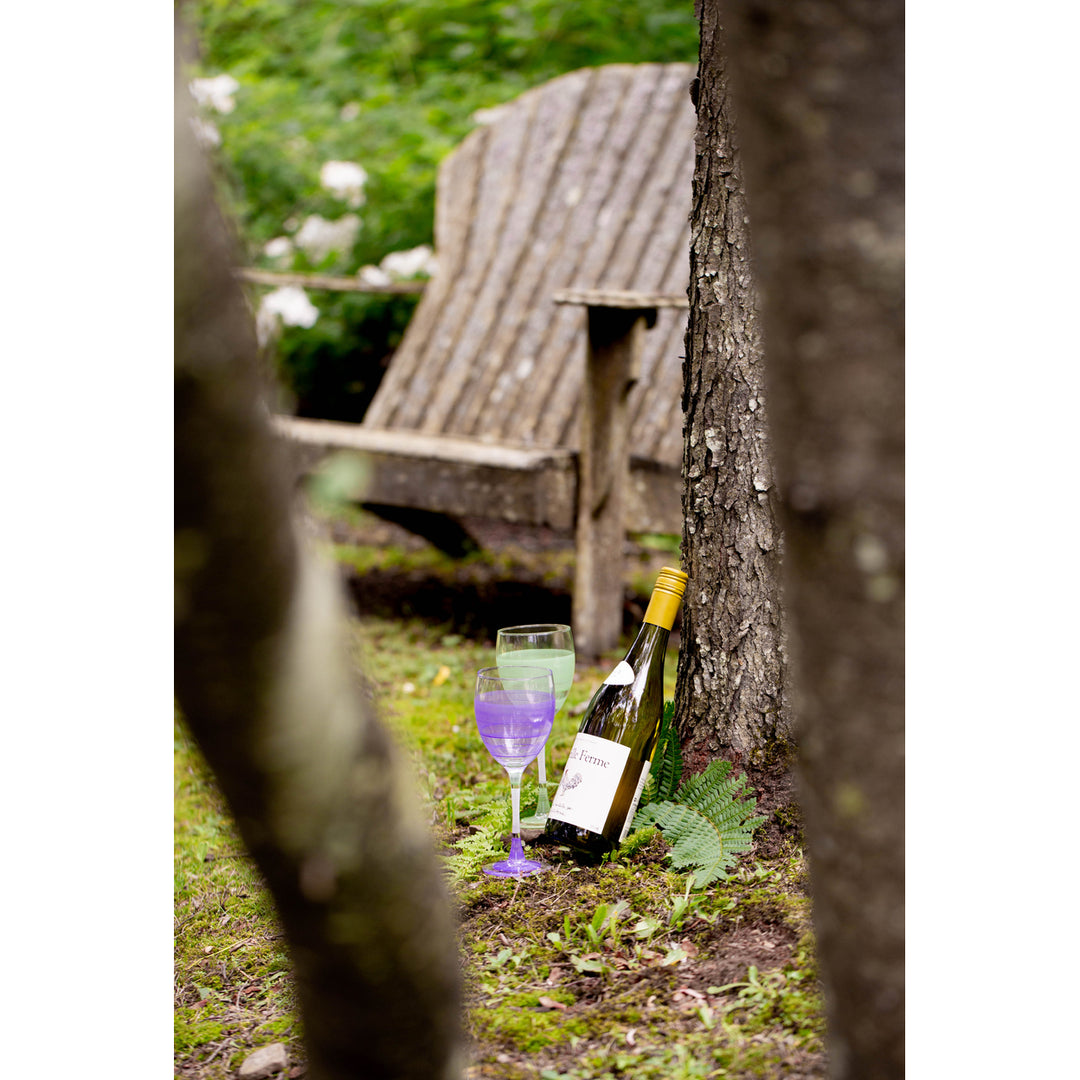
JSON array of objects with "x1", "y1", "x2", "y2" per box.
[{"x1": 364, "y1": 65, "x2": 693, "y2": 463}]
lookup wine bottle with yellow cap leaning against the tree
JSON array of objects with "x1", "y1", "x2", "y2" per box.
[{"x1": 544, "y1": 566, "x2": 687, "y2": 860}]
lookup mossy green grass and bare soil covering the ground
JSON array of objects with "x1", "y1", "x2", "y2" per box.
[{"x1": 174, "y1": 529, "x2": 824, "y2": 1080}]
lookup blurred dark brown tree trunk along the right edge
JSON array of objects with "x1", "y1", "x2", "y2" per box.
[{"x1": 721, "y1": 0, "x2": 904, "y2": 1080}]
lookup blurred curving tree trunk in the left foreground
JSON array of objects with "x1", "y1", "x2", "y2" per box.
[{"x1": 175, "y1": 35, "x2": 460, "y2": 1080}]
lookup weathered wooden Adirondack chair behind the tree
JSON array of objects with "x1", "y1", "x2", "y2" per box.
[{"x1": 279, "y1": 64, "x2": 694, "y2": 656}]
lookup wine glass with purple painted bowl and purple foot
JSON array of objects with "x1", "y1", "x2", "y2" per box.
[{"x1": 473, "y1": 664, "x2": 555, "y2": 877}]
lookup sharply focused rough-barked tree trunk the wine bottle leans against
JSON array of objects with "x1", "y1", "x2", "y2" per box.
[{"x1": 675, "y1": 6, "x2": 791, "y2": 772}]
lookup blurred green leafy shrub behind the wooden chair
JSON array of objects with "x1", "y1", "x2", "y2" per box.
[{"x1": 185, "y1": 0, "x2": 698, "y2": 419}]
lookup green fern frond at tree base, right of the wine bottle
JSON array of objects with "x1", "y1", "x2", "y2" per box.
[{"x1": 634, "y1": 761, "x2": 765, "y2": 888}]
